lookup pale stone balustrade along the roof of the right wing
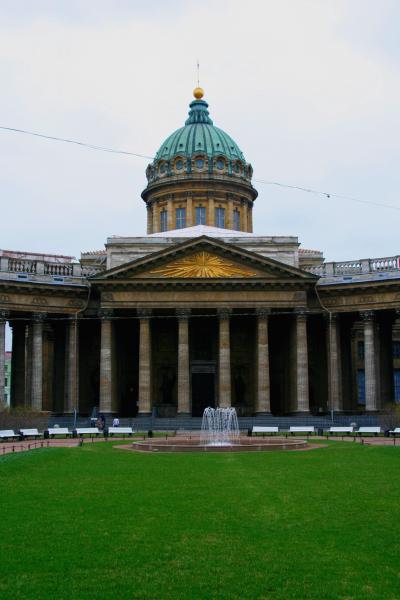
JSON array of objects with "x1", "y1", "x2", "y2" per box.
[{"x1": 305, "y1": 255, "x2": 400, "y2": 277}]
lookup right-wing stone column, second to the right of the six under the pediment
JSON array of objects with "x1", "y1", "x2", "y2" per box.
[{"x1": 361, "y1": 311, "x2": 378, "y2": 411}]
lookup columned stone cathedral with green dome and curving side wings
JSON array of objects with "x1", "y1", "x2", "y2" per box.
[{"x1": 0, "y1": 88, "x2": 400, "y2": 419}]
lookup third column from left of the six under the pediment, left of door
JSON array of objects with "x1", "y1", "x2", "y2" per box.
[{"x1": 176, "y1": 309, "x2": 191, "y2": 416}]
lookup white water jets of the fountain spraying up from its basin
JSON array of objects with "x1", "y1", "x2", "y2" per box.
[{"x1": 200, "y1": 406, "x2": 240, "y2": 446}]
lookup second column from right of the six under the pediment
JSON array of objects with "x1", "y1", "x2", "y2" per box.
[{"x1": 255, "y1": 308, "x2": 271, "y2": 414}]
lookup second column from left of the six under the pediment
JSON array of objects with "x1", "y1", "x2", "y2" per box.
[{"x1": 138, "y1": 309, "x2": 152, "y2": 416}]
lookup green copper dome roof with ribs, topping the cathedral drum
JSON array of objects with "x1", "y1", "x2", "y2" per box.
[{"x1": 155, "y1": 100, "x2": 246, "y2": 163}]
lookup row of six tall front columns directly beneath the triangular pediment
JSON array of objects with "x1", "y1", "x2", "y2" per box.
[{"x1": 100, "y1": 308, "x2": 310, "y2": 416}]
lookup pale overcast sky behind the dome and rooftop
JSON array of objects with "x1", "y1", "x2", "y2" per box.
[{"x1": 0, "y1": 0, "x2": 400, "y2": 260}]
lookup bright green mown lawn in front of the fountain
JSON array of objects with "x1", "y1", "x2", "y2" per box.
[{"x1": 0, "y1": 441, "x2": 400, "y2": 600}]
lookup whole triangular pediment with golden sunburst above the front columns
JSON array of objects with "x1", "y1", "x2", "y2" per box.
[{"x1": 94, "y1": 236, "x2": 317, "y2": 282}]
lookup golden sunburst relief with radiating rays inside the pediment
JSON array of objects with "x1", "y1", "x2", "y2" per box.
[{"x1": 150, "y1": 252, "x2": 257, "y2": 277}]
